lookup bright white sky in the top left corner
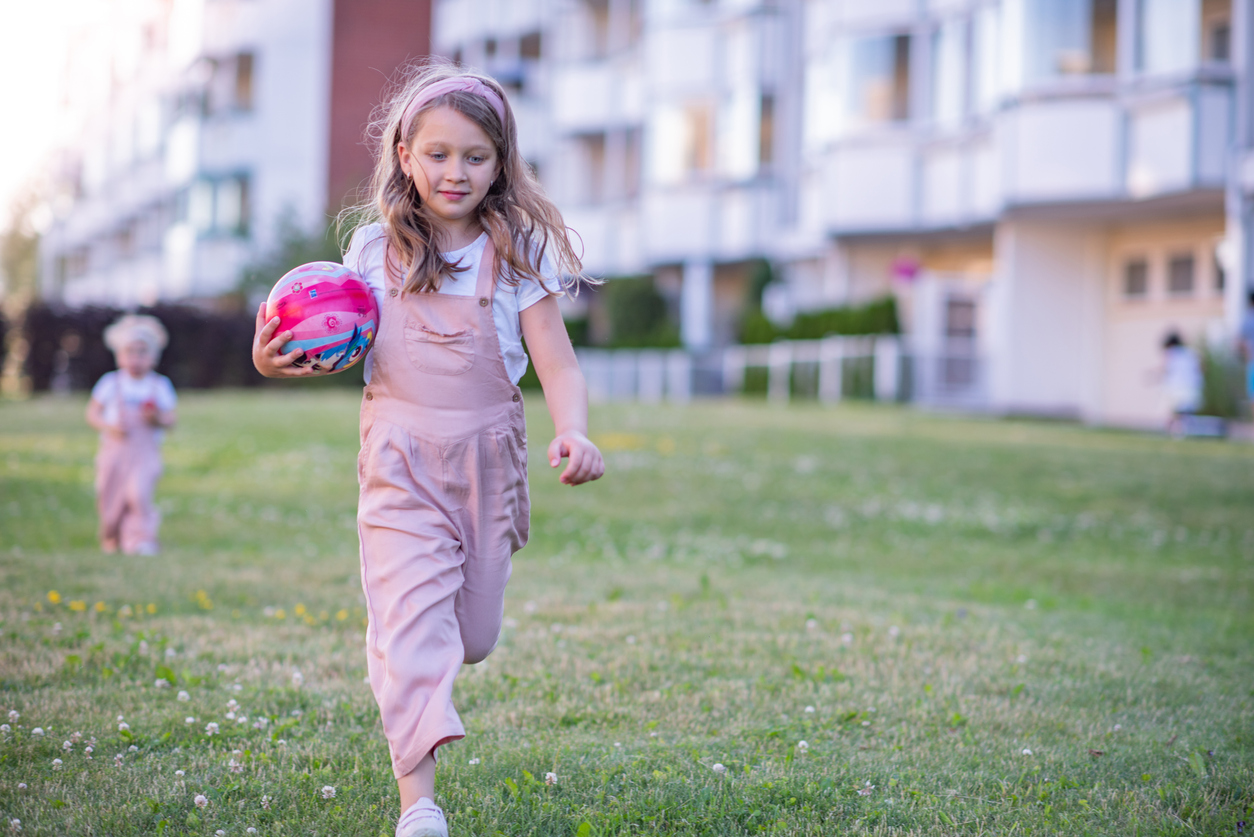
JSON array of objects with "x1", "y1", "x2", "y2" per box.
[{"x1": 0, "y1": 0, "x2": 102, "y2": 227}]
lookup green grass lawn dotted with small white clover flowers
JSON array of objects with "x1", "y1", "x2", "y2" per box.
[{"x1": 0, "y1": 390, "x2": 1254, "y2": 837}]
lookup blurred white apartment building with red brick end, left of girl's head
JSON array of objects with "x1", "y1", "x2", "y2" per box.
[{"x1": 40, "y1": 0, "x2": 430, "y2": 306}]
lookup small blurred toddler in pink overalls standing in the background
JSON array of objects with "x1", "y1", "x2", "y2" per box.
[{"x1": 87, "y1": 314, "x2": 177, "y2": 555}]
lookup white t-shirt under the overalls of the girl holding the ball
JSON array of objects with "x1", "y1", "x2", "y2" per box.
[{"x1": 344, "y1": 223, "x2": 561, "y2": 384}]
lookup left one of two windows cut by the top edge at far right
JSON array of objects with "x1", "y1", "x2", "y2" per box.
[{"x1": 1023, "y1": 0, "x2": 1118, "y2": 82}]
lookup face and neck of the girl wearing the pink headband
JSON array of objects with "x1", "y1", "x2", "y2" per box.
[{"x1": 396, "y1": 107, "x2": 500, "y2": 247}]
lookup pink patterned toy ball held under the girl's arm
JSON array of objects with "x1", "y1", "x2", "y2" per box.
[{"x1": 266, "y1": 261, "x2": 379, "y2": 375}]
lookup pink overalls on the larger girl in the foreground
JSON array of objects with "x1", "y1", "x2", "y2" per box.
[{"x1": 357, "y1": 241, "x2": 530, "y2": 778}]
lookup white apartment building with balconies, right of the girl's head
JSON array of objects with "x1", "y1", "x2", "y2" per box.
[{"x1": 434, "y1": 0, "x2": 1254, "y2": 425}]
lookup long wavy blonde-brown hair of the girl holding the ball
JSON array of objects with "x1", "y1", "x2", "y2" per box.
[{"x1": 349, "y1": 59, "x2": 586, "y2": 292}]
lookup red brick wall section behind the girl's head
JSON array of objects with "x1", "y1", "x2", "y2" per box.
[{"x1": 327, "y1": 0, "x2": 431, "y2": 212}]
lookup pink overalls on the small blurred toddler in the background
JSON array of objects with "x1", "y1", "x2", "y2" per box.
[{"x1": 95, "y1": 383, "x2": 162, "y2": 553}]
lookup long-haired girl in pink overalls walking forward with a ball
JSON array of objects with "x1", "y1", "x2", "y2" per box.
[{"x1": 253, "y1": 65, "x2": 604, "y2": 837}]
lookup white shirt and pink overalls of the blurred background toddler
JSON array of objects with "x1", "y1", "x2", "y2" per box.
[{"x1": 92, "y1": 371, "x2": 174, "y2": 553}]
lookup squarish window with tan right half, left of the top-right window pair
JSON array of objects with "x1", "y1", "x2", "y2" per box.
[{"x1": 844, "y1": 35, "x2": 910, "y2": 128}]
